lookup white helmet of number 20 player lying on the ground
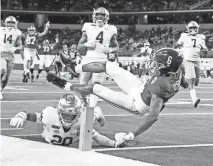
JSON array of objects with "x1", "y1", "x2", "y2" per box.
[{"x1": 58, "y1": 94, "x2": 83, "y2": 128}]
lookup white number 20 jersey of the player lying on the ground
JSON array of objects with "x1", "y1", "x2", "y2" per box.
[{"x1": 36, "y1": 107, "x2": 80, "y2": 146}]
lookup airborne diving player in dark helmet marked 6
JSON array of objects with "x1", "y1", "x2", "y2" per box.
[{"x1": 47, "y1": 48, "x2": 188, "y2": 144}]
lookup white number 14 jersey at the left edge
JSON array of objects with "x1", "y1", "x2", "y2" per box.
[{"x1": 0, "y1": 27, "x2": 22, "y2": 52}]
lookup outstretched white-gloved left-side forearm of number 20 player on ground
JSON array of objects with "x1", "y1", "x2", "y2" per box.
[{"x1": 10, "y1": 111, "x2": 41, "y2": 128}]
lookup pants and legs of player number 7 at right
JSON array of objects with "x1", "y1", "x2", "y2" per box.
[{"x1": 184, "y1": 60, "x2": 200, "y2": 108}]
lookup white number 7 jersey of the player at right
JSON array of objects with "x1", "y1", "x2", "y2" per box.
[{"x1": 178, "y1": 33, "x2": 206, "y2": 61}]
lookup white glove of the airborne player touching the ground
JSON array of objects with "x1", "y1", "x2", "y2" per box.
[{"x1": 115, "y1": 132, "x2": 135, "y2": 147}]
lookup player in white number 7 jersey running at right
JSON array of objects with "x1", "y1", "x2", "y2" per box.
[{"x1": 177, "y1": 21, "x2": 208, "y2": 108}]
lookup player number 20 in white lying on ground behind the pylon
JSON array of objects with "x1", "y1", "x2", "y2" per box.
[{"x1": 10, "y1": 94, "x2": 125, "y2": 147}]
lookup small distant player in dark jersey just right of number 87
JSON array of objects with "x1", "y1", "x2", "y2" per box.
[{"x1": 35, "y1": 39, "x2": 53, "y2": 79}]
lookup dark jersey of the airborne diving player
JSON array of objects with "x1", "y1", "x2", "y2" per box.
[{"x1": 141, "y1": 71, "x2": 182, "y2": 105}]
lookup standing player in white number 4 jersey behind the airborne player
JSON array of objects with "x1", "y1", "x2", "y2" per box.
[{"x1": 61, "y1": 7, "x2": 119, "y2": 107}]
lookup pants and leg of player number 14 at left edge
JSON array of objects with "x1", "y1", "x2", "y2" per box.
[{"x1": 0, "y1": 52, "x2": 14, "y2": 99}]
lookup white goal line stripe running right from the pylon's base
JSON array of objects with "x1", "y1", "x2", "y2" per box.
[{"x1": 93, "y1": 144, "x2": 213, "y2": 152}]
